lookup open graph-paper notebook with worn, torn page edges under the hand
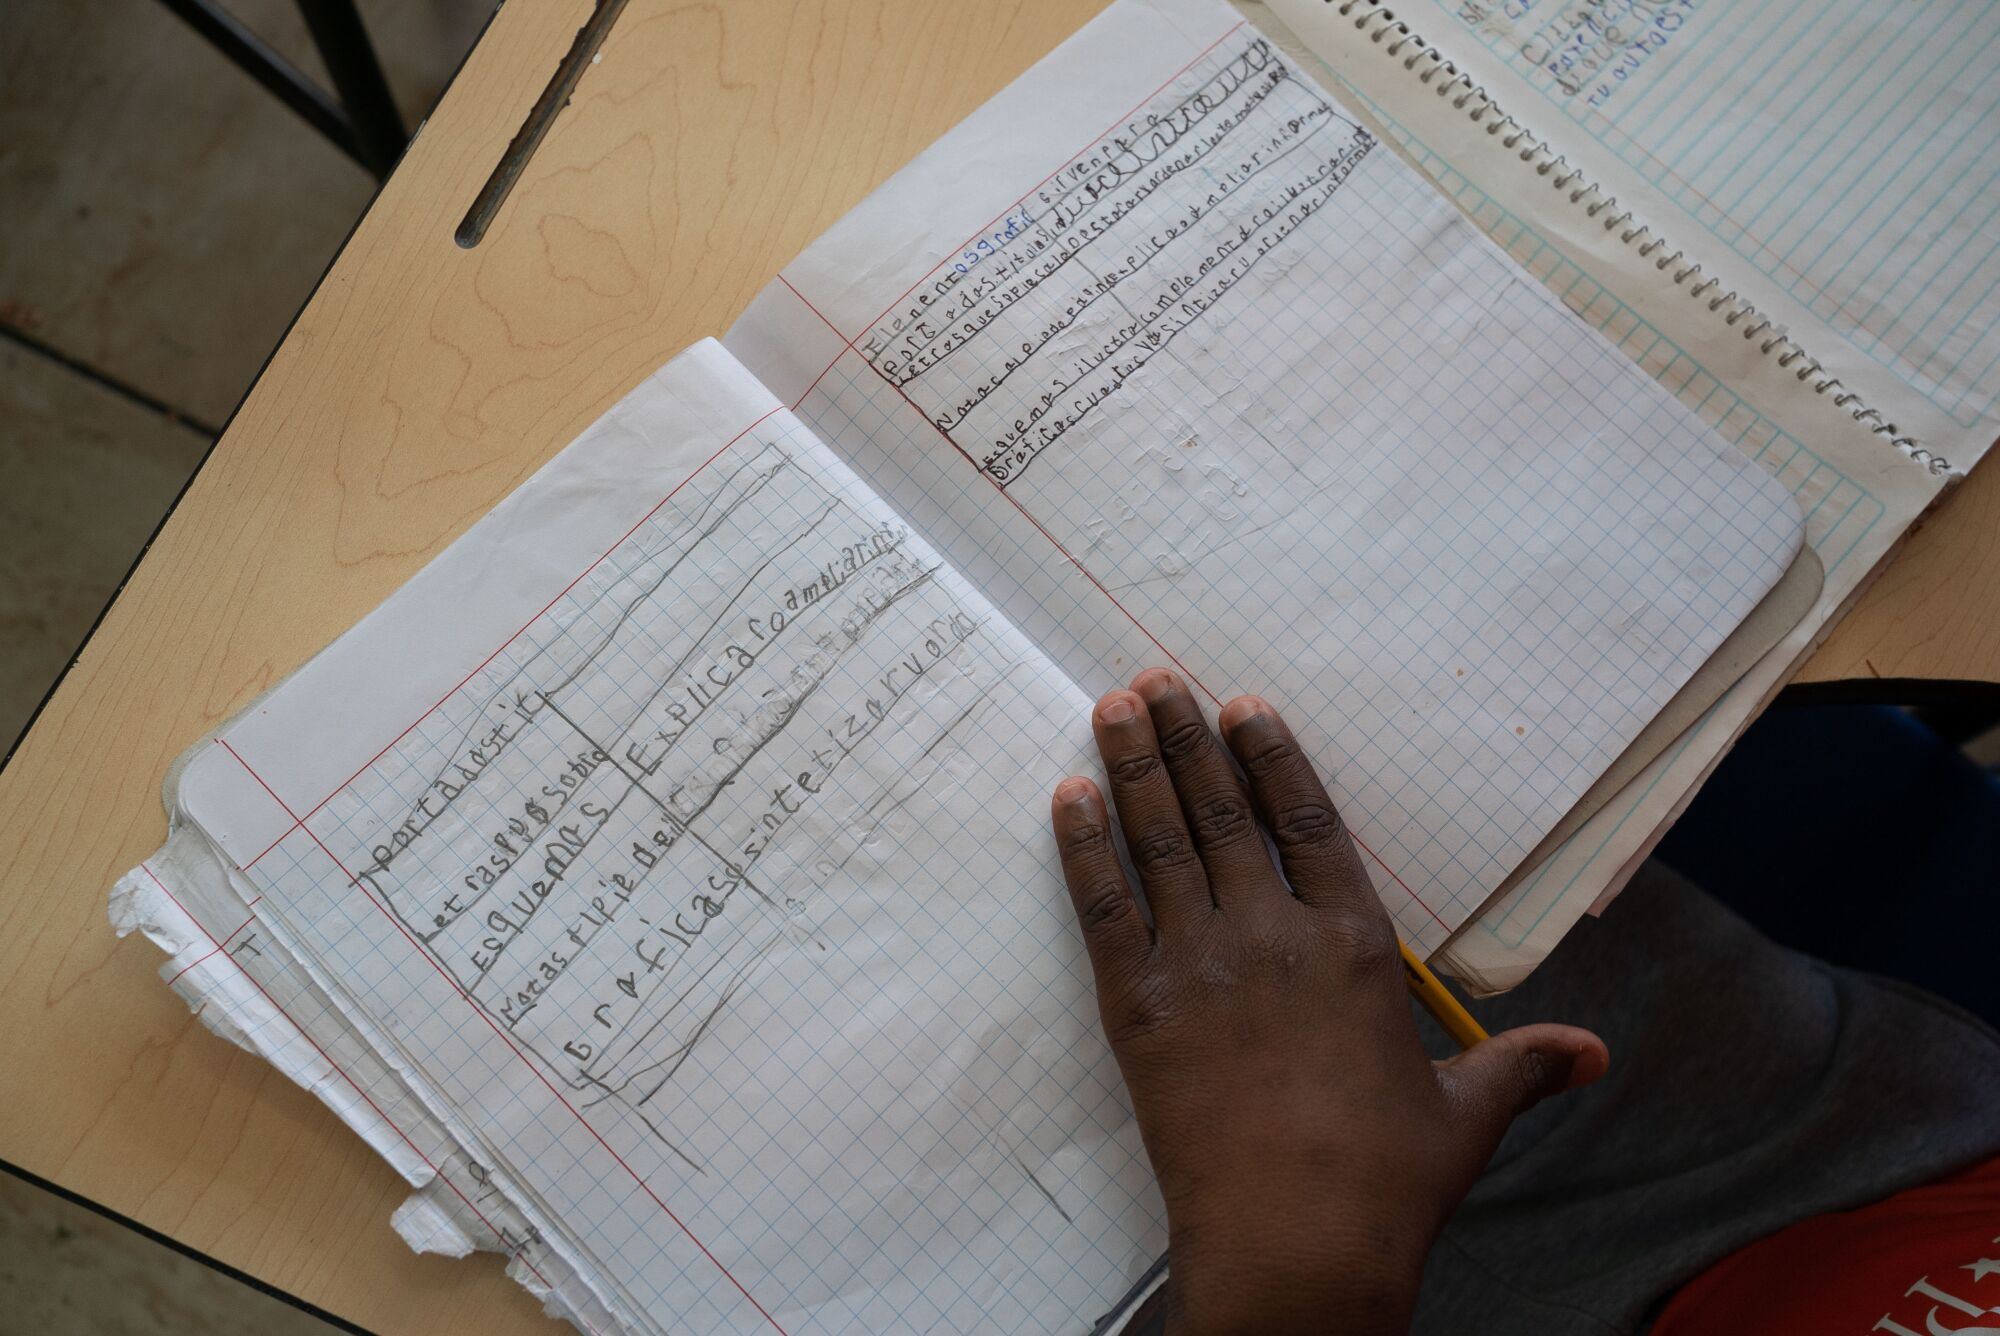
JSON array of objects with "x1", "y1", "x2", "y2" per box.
[{"x1": 114, "y1": 0, "x2": 1952, "y2": 1332}]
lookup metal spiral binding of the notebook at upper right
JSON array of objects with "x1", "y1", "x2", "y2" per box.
[{"x1": 1322, "y1": 0, "x2": 1958, "y2": 474}]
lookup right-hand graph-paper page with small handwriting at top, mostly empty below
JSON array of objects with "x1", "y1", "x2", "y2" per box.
[{"x1": 726, "y1": 0, "x2": 1804, "y2": 948}]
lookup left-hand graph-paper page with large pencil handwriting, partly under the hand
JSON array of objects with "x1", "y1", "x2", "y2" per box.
[{"x1": 180, "y1": 344, "x2": 1164, "y2": 1332}]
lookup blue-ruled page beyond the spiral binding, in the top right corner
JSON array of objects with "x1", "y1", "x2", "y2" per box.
[{"x1": 1274, "y1": 0, "x2": 2000, "y2": 470}]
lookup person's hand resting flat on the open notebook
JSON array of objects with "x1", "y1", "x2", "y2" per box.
[{"x1": 1054, "y1": 668, "x2": 1610, "y2": 1336}]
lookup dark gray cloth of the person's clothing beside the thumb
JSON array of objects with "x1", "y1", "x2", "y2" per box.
[{"x1": 1414, "y1": 864, "x2": 2000, "y2": 1336}]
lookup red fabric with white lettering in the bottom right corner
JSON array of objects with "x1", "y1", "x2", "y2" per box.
[{"x1": 1652, "y1": 1160, "x2": 2000, "y2": 1336}]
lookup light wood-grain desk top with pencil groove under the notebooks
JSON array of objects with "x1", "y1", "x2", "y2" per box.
[{"x1": 0, "y1": 0, "x2": 2000, "y2": 1336}]
